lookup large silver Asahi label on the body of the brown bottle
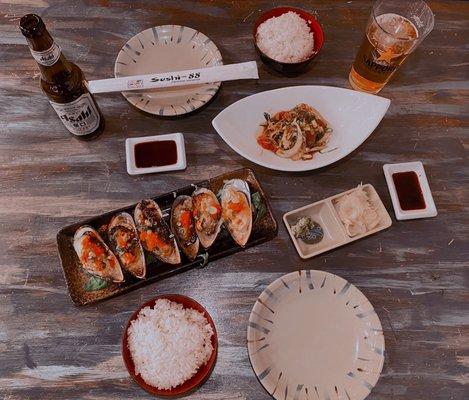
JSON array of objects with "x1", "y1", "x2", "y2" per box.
[{"x1": 50, "y1": 93, "x2": 100, "y2": 136}]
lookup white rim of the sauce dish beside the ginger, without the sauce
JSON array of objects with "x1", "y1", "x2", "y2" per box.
[{"x1": 383, "y1": 161, "x2": 438, "y2": 220}]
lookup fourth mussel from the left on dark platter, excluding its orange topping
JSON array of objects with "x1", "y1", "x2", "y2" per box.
[{"x1": 170, "y1": 195, "x2": 199, "y2": 260}]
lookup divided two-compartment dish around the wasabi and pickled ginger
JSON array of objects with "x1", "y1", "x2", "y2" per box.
[{"x1": 283, "y1": 184, "x2": 392, "y2": 259}]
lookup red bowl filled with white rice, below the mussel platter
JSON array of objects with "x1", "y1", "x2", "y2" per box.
[{"x1": 122, "y1": 294, "x2": 218, "y2": 397}]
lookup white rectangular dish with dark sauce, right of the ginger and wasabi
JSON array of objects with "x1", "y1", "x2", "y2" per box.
[{"x1": 383, "y1": 161, "x2": 438, "y2": 220}]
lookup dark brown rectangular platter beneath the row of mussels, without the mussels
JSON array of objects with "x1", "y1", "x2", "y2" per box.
[{"x1": 57, "y1": 168, "x2": 278, "y2": 305}]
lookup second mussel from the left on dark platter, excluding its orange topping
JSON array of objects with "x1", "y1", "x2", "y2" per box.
[{"x1": 108, "y1": 212, "x2": 146, "y2": 279}]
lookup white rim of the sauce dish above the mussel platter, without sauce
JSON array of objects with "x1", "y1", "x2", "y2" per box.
[{"x1": 125, "y1": 133, "x2": 187, "y2": 175}]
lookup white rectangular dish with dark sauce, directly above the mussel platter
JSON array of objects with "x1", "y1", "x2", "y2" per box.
[{"x1": 125, "y1": 133, "x2": 187, "y2": 175}]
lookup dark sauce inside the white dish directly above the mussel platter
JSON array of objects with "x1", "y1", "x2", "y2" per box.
[{"x1": 134, "y1": 140, "x2": 178, "y2": 168}]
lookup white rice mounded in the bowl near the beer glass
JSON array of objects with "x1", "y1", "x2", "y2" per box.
[{"x1": 256, "y1": 11, "x2": 314, "y2": 63}]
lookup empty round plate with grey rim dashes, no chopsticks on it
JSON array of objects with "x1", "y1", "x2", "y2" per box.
[{"x1": 247, "y1": 270, "x2": 384, "y2": 400}]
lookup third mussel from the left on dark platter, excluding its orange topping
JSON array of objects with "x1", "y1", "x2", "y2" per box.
[{"x1": 134, "y1": 199, "x2": 181, "y2": 264}]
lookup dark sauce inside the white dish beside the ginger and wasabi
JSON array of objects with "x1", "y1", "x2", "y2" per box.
[{"x1": 392, "y1": 171, "x2": 426, "y2": 211}]
